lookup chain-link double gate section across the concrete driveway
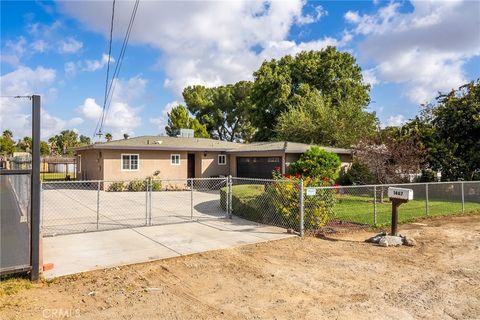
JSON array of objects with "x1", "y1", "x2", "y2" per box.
[{"x1": 41, "y1": 178, "x2": 228, "y2": 236}]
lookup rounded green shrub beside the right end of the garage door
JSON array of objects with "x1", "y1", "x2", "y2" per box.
[{"x1": 289, "y1": 146, "x2": 341, "y2": 180}]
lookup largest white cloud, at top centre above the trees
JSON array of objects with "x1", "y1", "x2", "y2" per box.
[{"x1": 59, "y1": 0, "x2": 348, "y2": 98}]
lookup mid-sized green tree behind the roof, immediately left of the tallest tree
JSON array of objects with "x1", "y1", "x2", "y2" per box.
[{"x1": 183, "y1": 81, "x2": 255, "y2": 141}]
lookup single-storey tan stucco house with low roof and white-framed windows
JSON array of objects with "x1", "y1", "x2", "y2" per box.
[{"x1": 73, "y1": 136, "x2": 352, "y2": 181}]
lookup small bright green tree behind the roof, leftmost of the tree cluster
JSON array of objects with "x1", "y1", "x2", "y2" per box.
[{"x1": 165, "y1": 105, "x2": 210, "y2": 138}]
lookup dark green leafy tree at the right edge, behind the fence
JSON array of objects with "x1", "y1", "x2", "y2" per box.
[{"x1": 403, "y1": 80, "x2": 480, "y2": 180}]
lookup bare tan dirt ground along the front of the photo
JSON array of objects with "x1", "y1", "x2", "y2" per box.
[{"x1": 0, "y1": 215, "x2": 480, "y2": 319}]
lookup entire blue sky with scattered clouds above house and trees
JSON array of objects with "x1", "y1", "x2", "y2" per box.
[{"x1": 0, "y1": 0, "x2": 480, "y2": 139}]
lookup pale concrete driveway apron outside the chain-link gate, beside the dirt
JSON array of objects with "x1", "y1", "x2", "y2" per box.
[{"x1": 43, "y1": 217, "x2": 292, "y2": 279}]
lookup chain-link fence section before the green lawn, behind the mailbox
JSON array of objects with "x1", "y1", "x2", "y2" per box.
[{"x1": 306, "y1": 181, "x2": 480, "y2": 232}]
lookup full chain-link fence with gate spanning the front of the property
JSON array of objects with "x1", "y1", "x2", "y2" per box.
[{"x1": 42, "y1": 177, "x2": 480, "y2": 235}]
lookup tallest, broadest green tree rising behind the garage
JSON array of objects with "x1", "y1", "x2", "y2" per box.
[{"x1": 251, "y1": 47, "x2": 376, "y2": 145}]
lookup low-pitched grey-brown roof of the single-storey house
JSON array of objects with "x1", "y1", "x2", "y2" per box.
[{"x1": 73, "y1": 136, "x2": 351, "y2": 154}]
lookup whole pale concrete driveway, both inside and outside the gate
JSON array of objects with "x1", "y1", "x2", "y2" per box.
[{"x1": 42, "y1": 183, "x2": 291, "y2": 278}]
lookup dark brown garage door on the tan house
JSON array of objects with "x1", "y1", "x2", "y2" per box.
[{"x1": 237, "y1": 157, "x2": 282, "y2": 179}]
